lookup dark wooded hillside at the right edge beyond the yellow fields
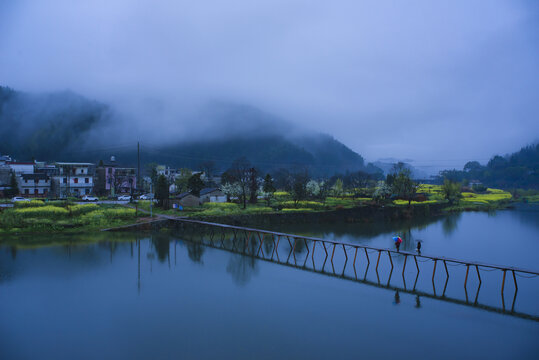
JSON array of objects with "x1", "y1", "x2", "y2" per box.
[{"x1": 438, "y1": 143, "x2": 539, "y2": 189}]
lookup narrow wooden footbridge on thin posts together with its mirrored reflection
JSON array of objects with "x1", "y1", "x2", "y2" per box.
[{"x1": 170, "y1": 218, "x2": 539, "y2": 321}]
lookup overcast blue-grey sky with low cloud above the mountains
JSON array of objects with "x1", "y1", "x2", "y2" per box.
[{"x1": 0, "y1": 0, "x2": 539, "y2": 172}]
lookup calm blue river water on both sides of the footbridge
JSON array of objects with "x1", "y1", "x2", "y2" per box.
[{"x1": 0, "y1": 207, "x2": 539, "y2": 359}]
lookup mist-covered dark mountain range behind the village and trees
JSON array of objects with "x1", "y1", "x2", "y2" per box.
[{"x1": 0, "y1": 87, "x2": 372, "y2": 176}]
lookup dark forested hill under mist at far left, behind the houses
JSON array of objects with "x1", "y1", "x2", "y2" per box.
[{"x1": 0, "y1": 86, "x2": 107, "y2": 161}]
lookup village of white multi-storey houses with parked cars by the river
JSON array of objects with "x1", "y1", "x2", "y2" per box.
[{"x1": 0, "y1": 155, "x2": 227, "y2": 207}]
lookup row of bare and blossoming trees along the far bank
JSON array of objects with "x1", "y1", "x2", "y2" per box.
[{"x1": 155, "y1": 157, "x2": 426, "y2": 208}]
